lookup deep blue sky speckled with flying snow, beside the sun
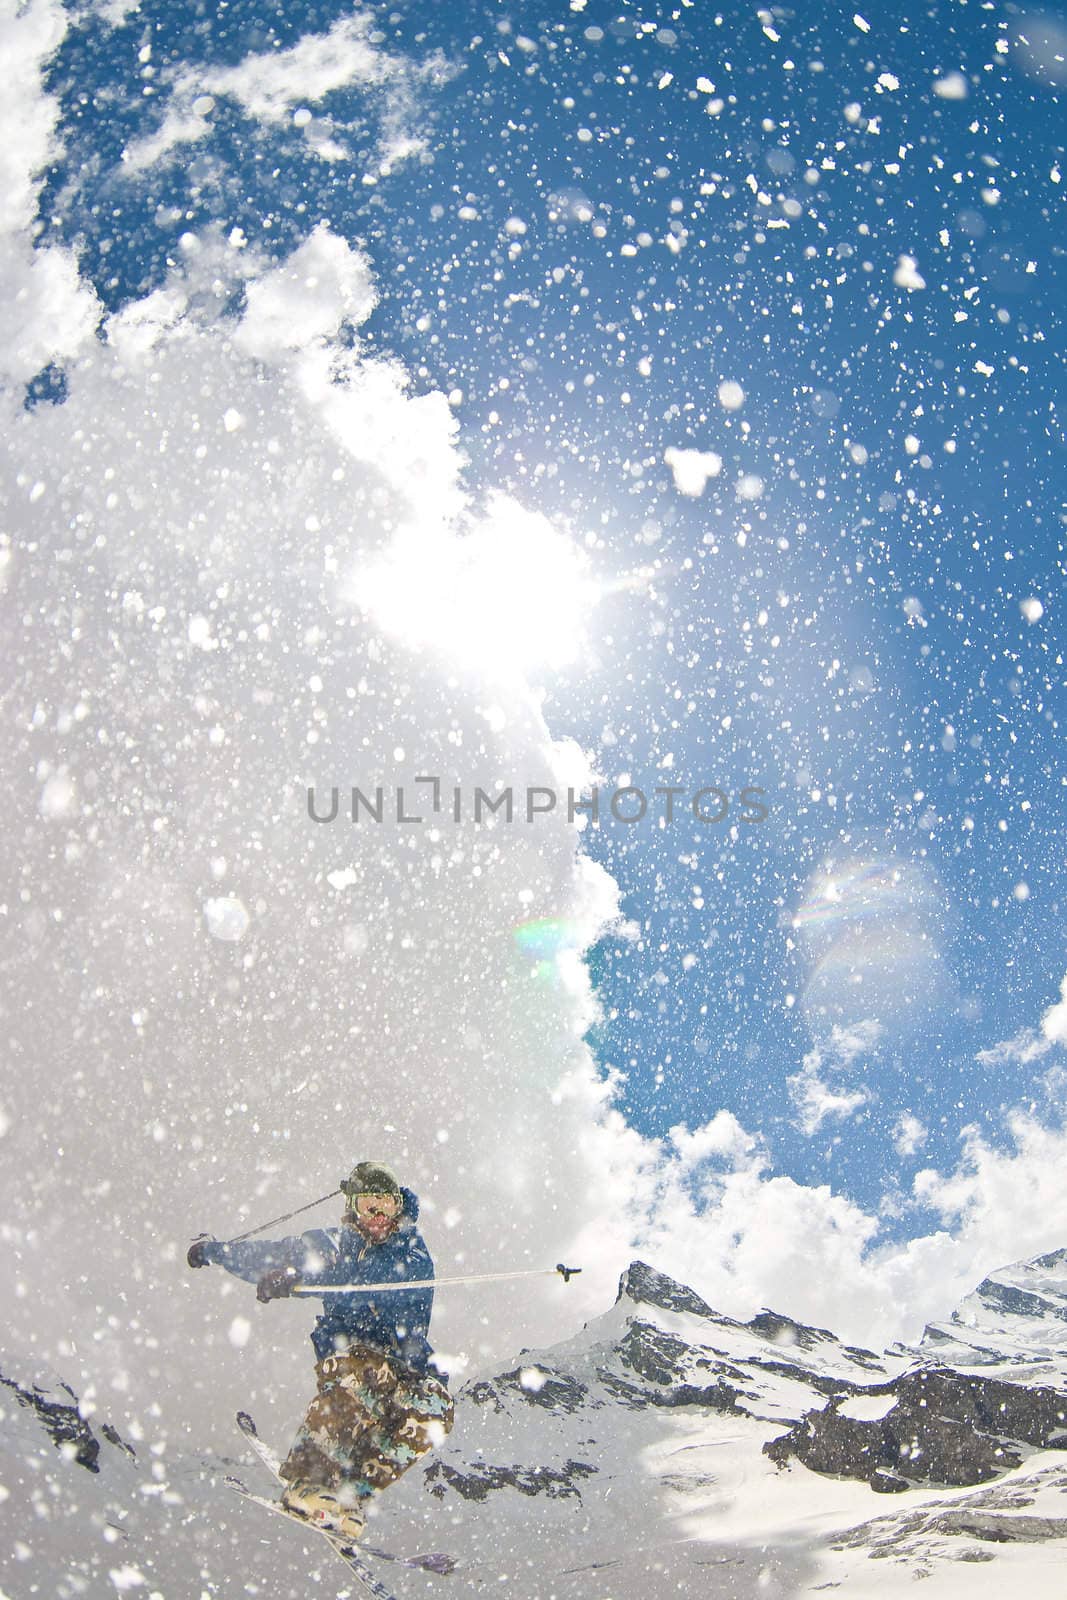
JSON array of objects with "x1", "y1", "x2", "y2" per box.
[{"x1": 40, "y1": 0, "x2": 1067, "y2": 1234}]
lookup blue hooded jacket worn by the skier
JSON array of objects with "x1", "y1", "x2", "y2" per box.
[{"x1": 205, "y1": 1189, "x2": 440, "y2": 1376}]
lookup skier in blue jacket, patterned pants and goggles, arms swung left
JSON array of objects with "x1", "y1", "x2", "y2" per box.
[{"x1": 187, "y1": 1162, "x2": 453, "y2": 1539}]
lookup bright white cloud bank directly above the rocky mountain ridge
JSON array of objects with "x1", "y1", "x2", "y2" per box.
[{"x1": 576, "y1": 1114, "x2": 1067, "y2": 1349}]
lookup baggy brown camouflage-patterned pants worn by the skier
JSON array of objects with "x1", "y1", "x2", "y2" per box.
[{"x1": 282, "y1": 1346, "x2": 453, "y2": 1498}]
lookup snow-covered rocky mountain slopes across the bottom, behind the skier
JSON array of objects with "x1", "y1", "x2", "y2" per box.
[{"x1": 0, "y1": 1251, "x2": 1067, "y2": 1600}]
